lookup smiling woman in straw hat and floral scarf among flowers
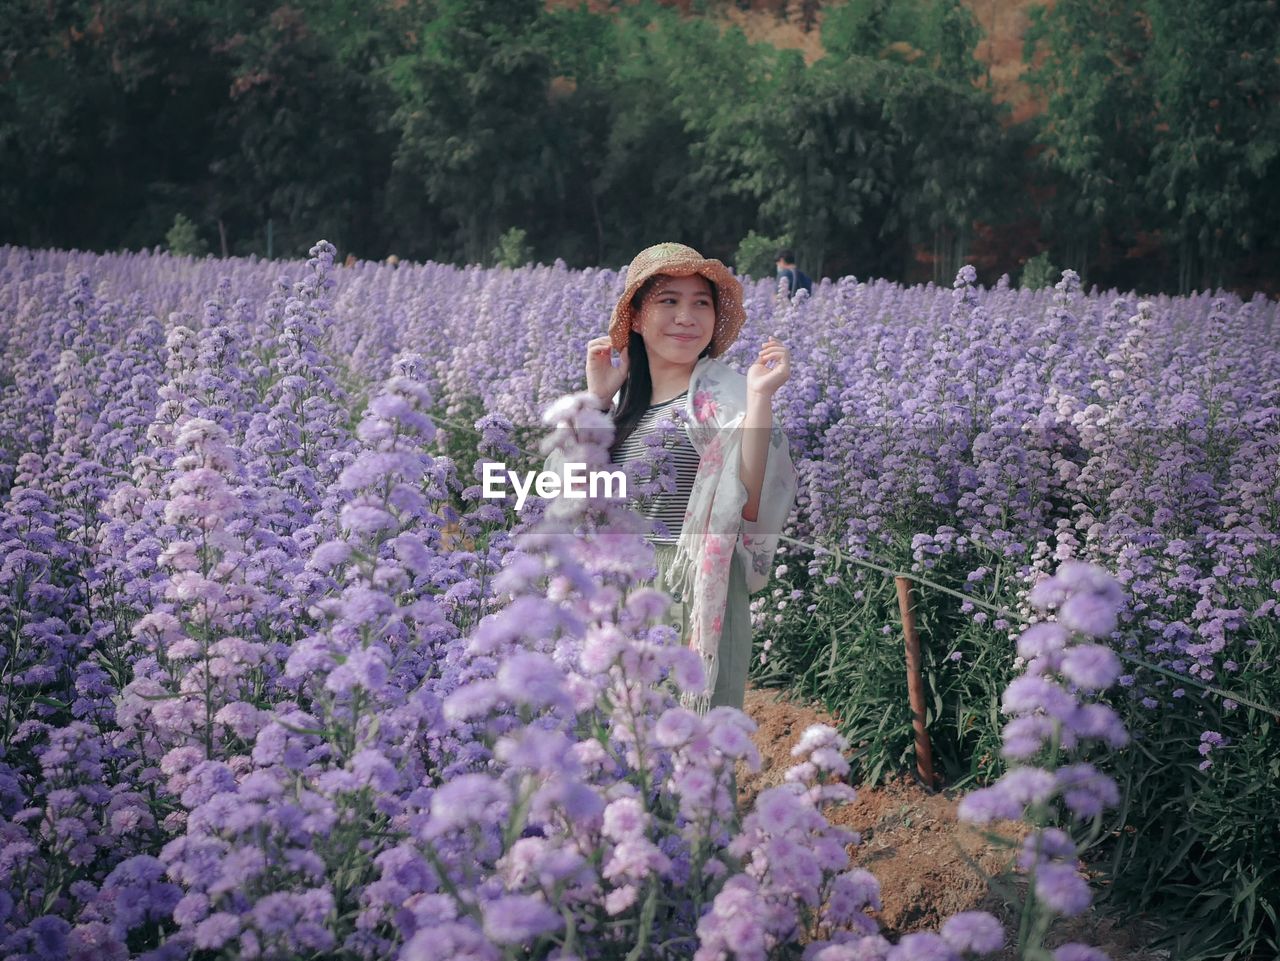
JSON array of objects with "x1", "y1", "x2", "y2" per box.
[{"x1": 586, "y1": 243, "x2": 796, "y2": 710}]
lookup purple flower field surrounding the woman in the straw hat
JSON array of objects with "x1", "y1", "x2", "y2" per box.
[{"x1": 0, "y1": 242, "x2": 1280, "y2": 961}]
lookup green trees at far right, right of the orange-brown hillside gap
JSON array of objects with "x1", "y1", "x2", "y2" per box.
[{"x1": 1028, "y1": 0, "x2": 1280, "y2": 290}]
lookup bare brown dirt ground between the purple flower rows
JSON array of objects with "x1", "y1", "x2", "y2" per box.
[{"x1": 739, "y1": 690, "x2": 1169, "y2": 961}]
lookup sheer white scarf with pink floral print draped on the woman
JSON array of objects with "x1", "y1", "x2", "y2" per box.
[{"x1": 667, "y1": 357, "x2": 796, "y2": 713}]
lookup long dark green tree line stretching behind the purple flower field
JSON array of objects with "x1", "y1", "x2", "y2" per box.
[{"x1": 0, "y1": 0, "x2": 1280, "y2": 289}]
